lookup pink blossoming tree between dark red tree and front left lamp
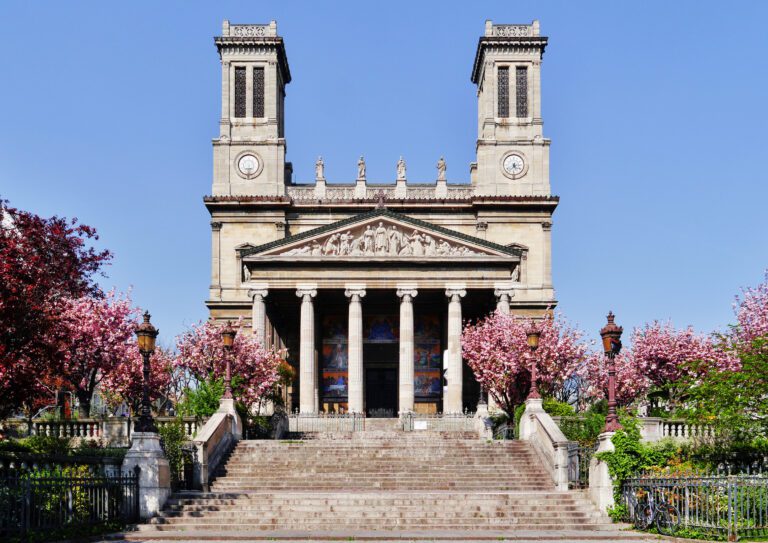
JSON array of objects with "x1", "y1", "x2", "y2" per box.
[{"x1": 51, "y1": 292, "x2": 139, "y2": 417}]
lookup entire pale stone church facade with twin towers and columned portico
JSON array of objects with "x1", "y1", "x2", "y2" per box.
[{"x1": 204, "y1": 21, "x2": 558, "y2": 416}]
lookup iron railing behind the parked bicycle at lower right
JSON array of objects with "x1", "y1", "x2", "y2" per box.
[{"x1": 622, "y1": 474, "x2": 768, "y2": 541}]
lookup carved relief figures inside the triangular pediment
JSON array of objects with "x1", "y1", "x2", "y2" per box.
[{"x1": 277, "y1": 221, "x2": 490, "y2": 257}]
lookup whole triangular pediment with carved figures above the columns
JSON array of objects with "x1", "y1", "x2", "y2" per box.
[{"x1": 241, "y1": 210, "x2": 520, "y2": 261}]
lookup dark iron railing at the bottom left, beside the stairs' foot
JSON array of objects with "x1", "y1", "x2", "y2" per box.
[{"x1": 0, "y1": 466, "x2": 139, "y2": 541}]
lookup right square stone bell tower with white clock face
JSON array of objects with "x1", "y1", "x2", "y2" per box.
[{"x1": 472, "y1": 21, "x2": 550, "y2": 196}]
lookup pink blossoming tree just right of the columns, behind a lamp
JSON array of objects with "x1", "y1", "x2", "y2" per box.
[{"x1": 461, "y1": 311, "x2": 588, "y2": 414}]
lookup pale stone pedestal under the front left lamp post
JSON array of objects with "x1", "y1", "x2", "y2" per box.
[{"x1": 123, "y1": 432, "x2": 171, "y2": 519}]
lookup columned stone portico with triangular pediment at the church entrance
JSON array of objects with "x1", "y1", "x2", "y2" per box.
[{"x1": 240, "y1": 207, "x2": 524, "y2": 416}]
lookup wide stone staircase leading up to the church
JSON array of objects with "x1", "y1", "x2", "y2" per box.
[{"x1": 135, "y1": 430, "x2": 636, "y2": 541}]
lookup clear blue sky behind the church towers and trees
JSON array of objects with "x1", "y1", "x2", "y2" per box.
[{"x1": 0, "y1": 0, "x2": 768, "y2": 342}]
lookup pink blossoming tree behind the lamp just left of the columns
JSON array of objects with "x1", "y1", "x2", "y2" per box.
[{"x1": 174, "y1": 320, "x2": 285, "y2": 406}]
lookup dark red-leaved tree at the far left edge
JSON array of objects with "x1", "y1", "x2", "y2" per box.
[{"x1": 0, "y1": 200, "x2": 111, "y2": 416}]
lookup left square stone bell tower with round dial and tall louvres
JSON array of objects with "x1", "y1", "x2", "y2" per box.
[{"x1": 213, "y1": 20, "x2": 291, "y2": 196}]
